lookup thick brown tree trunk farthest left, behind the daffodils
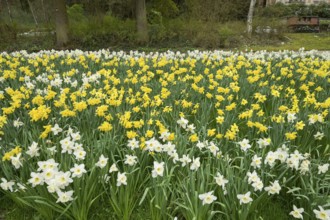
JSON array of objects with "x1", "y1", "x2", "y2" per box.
[{"x1": 54, "y1": 0, "x2": 69, "y2": 48}]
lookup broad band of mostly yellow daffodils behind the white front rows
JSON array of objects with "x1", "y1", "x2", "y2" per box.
[{"x1": 0, "y1": 52, "x2": 330, "y2": 146}]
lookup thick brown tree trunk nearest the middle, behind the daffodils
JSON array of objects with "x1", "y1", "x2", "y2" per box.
[{"x1": 135, "y1": 0, "x2": 149, "y2": 43}]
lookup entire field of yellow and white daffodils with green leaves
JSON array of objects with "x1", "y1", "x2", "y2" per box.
[{"x1": 0, "y1": 50, "x2": 330, "y2": 220}]
